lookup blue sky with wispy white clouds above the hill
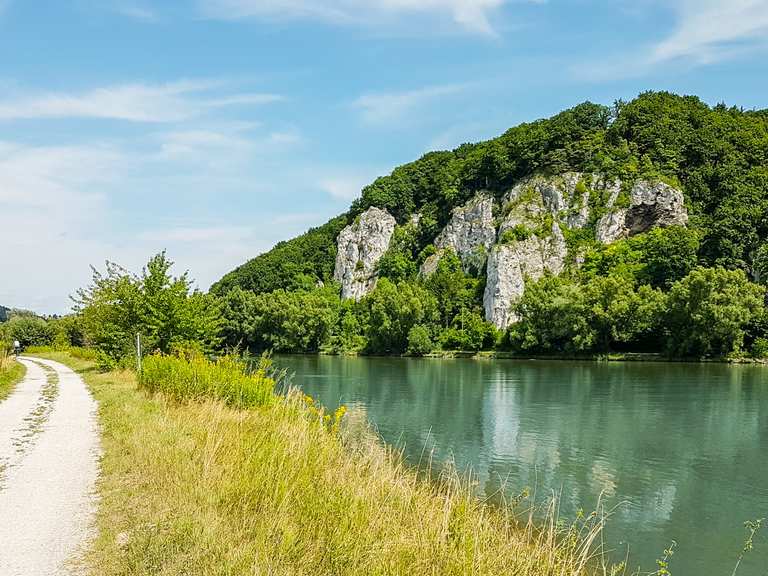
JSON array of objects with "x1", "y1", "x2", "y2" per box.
[{"x1": 0, "y1": 0, "x2": 768, "y2": 314}]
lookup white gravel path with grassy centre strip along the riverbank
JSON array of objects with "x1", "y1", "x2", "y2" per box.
[{"x1": 0, "y1": 358, "x2": 99, "y2": 576}]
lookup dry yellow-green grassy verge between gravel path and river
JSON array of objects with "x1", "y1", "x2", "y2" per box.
[{"x1": 34, "y1": 353, "x2": 612, "y2": 576}]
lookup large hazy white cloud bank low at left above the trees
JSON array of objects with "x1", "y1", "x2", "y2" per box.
[{"x1": 0, "y1": 122, "x2": 322, "y2": 313}]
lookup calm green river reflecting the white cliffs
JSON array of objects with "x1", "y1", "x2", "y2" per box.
[{"x1": 276, "y1": 356, "x2": 768, "y2": 576}]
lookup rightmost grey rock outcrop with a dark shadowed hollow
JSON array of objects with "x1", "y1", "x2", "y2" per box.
[{"x1": 596, "y1": 180, "x2": 688, "y2": 244}]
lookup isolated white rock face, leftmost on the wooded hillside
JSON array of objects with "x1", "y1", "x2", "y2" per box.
[{"x1": 333, "y1": 206, "x2": 396, "y2": 300}]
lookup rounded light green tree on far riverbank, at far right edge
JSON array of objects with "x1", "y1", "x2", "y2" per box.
[{"x1": 667, "y1": 268, "x2": 765, "y2": 357}]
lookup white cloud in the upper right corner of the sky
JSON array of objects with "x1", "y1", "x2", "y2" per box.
[{"x1": 650, "y1": 0, "x2": 768, "y2": 63}]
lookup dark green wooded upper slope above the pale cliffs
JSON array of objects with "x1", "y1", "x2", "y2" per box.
[{"x1": 214, "y1": 92, "x2": 768, "y2": 293}]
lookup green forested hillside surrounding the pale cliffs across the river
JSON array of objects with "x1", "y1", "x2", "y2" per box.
[{"x1": 212, "y1": 92, "x2": 768, "y2": 356}]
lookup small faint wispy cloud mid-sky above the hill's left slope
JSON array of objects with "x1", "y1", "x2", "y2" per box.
[{"x1": 352, "y1": 84, "x2": 467, "y2": 124}]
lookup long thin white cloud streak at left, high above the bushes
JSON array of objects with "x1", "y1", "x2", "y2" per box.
[{"x1": 0, "y1": 81, "x2": 281, "y2": 122}]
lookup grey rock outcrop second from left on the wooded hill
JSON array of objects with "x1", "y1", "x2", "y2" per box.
[{"x1": 422, "y1": 192, "x2": 496, "y2": 275}]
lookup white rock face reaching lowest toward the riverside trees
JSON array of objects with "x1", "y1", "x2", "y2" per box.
[{"x1": 483, "y1": 222, "x2": 568, "y2": 330}]
